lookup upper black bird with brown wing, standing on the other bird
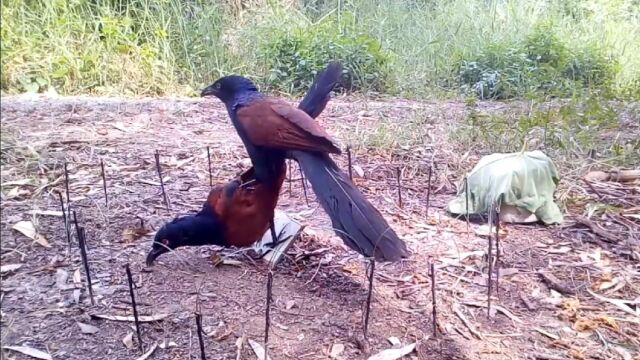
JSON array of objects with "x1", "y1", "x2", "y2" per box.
[{"x1": 200, "y1": 62, "x2": 409, "y2": 262}]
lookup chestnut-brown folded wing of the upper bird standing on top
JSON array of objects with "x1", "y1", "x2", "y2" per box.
[{"x1": 238, "y1": 100, "x2": 341, "y2": 154}]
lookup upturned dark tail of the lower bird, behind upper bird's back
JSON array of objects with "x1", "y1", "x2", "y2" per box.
[{"x1": 298, "y1": 62, "x2": 342, "y2": 119}]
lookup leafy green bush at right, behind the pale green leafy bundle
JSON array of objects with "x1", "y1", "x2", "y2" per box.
[{"x1": 458, "y1": 25, "x2": 618, "y2": 99}]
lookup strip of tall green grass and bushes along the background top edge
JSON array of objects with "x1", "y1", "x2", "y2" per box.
[{"x1": 1, "y1": 0, "x2": 640, "y2": 99}]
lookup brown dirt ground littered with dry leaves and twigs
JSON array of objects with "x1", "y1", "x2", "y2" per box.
[{"x1": 1, "y1": 93, "x2": 640, "y2": 360}]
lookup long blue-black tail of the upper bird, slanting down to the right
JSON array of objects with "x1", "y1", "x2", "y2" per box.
[{"x1": 289, "y1": 151, "x2": 408, "y2": 261}]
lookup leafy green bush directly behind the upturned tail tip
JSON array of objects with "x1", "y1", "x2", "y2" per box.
[{"x1": 252, "y1": 14, "x2": 392, "y2": 93}]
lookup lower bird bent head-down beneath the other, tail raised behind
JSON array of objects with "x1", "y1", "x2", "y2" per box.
[{"x1": 146, "y1": 63, "x2": 340, "y2": 266}]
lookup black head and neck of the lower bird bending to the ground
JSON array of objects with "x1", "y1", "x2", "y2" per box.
[{"x1": 146, "y1": 215, "x2": 224, "y2": 266}]
